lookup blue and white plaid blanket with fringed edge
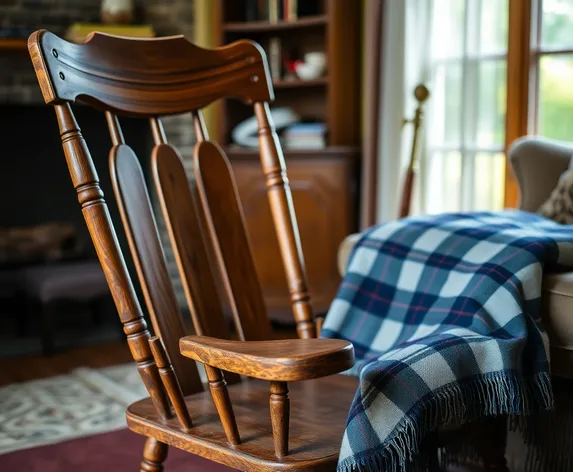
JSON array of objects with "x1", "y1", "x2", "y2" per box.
[{"x1": 321, "y1": 211, "x2": 573, "y2": 471}]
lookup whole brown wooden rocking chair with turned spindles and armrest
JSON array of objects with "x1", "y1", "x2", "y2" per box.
[{"x1": 28, "y1": 31, "x2": 357, "y2": 472}]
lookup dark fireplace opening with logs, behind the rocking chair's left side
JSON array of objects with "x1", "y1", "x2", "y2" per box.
[{"x1": 0, "y1": 104, "x2": 153, "y2": 357}]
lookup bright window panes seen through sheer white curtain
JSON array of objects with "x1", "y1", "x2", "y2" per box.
[{"x1": 420, "y1": 0, "x2": 509, "y2": 213}]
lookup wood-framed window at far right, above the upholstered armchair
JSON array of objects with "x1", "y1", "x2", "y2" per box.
[{"x1": 505, "y1": 0, "x2": 573, "y2": 207}]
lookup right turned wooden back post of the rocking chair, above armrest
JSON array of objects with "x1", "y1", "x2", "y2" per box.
[{"x1": 254, "y1": 102, "x2": 316, "y2": 339}]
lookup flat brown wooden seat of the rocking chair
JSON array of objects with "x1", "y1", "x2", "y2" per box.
[{"x1": 127, "y1": 375, "x2": 358, "y2": 471}]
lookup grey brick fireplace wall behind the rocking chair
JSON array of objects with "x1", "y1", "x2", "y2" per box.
[{"x1": 0, "y1": 0, "x2": 194, "y2": 304}]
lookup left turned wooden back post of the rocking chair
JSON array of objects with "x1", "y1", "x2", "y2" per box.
[{"x1": 54, "y1": 102, "x2": 170, "y2": 419}]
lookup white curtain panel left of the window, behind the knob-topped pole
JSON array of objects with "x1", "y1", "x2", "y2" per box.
[{"x1": 376, "y1": 0, "x2": 433, "y2": 222}]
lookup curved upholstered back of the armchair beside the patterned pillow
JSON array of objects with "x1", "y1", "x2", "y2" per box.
[{"x1": 508, "y1": 136, "x2": 573, "y2": 211}]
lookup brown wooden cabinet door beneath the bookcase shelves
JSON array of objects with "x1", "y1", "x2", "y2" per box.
[{"x1": 232, "y1": 156, "x2": 355, "y2": 323}]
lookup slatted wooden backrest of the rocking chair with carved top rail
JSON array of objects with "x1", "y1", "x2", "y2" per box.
[{"x1": 28, "y1": 30, "x2": 316, "y2": 410}]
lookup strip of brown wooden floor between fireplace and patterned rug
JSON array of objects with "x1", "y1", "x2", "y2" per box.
[{"x1": 0, "y1": 329, "x2": 296, "y2": 387}]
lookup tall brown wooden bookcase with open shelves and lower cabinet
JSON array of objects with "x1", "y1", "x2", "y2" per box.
[{"x1": 214, "y1": 0, "x2": 361, "y2": 322}]
